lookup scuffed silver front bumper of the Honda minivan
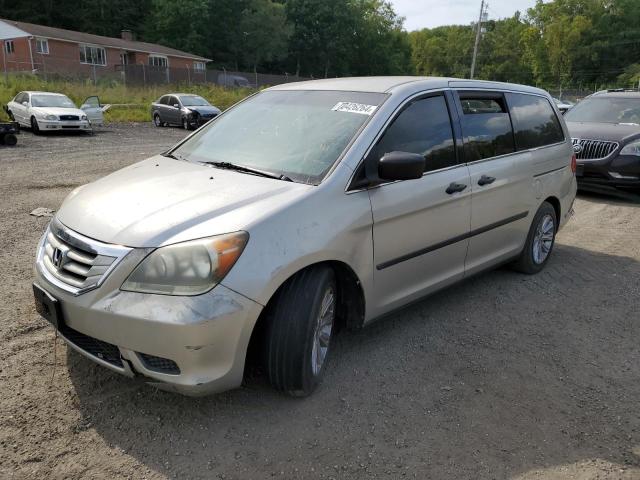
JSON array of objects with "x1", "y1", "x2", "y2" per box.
[{"x1": 35, "y1": 250, "x2": 262, "y2": 396}]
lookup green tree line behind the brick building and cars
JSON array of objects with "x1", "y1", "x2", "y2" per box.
[{"x1": 0, "y1": 0, "x2": 640, "y2": 89}]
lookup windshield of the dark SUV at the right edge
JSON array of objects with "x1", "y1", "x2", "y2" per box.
[{"x1": 564, "y1": 97, "x2": 640, "y2": 124}]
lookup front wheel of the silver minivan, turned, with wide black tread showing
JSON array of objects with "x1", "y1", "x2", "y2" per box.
[{"x1": 264, "y1": 266, "x2": 338, "y2": 397}]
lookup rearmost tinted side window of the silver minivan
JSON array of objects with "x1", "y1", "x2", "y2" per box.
[{"x1": 506, "y1": 93, "x2": 564, "y2": 150}]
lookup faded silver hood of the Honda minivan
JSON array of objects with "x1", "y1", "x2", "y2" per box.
[{"x1": 56, "y1": 156, "x2": 314, "y2": 247}]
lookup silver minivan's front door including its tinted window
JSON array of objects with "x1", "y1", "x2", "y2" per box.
[{"x1": 367, "y1": 94, "x2": 471, "y2": 316}]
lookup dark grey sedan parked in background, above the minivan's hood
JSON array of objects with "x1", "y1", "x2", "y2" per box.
[{"x1": 151, "y1": 93, "x2": 221, "y2": 130}]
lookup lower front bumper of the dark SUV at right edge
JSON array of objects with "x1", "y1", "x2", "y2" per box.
[{"x1": 576, "y1": 155, "x2": 640, "y2": 188}]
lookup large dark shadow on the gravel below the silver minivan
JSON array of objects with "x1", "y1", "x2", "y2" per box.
[{"x1": 67, "y1": 244, "x2": 640, "y2": 479}]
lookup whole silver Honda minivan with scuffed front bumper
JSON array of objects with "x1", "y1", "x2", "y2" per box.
[{"x1": 34, "y1": 77, "x2": 576, "y2": 396}]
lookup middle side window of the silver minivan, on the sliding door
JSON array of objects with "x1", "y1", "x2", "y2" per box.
[{"x1": 460, "y1": 93, "x2": 515, "y2": 162}]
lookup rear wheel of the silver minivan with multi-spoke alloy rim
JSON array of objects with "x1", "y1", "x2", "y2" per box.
[{"x1": 513, "y1": 202, "x2": 558, "y2": 275}]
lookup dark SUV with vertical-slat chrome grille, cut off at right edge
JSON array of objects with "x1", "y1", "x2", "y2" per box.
[{"x1": 565, "y1": 91, "x2": 640, "y2": 191}]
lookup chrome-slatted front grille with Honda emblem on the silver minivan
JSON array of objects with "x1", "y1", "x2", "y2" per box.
[{"x1": 38, "y1": 219, "x2": 131, "y2": 295}]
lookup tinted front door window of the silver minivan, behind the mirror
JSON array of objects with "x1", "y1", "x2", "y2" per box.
[{"x1": 372, "y1": 97, "x2": 456, "y2": 172}]
